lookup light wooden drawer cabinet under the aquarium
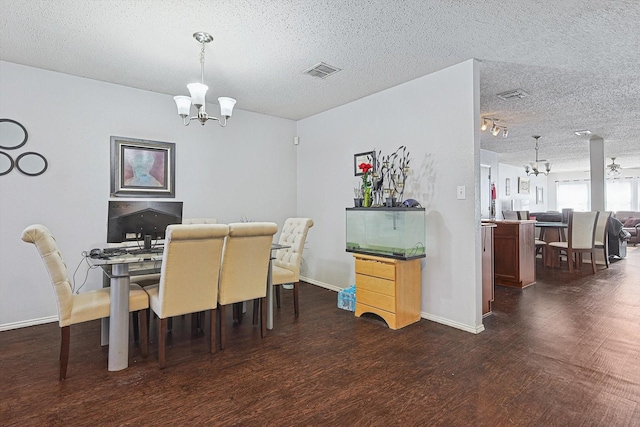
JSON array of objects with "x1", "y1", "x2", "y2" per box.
[{"x1": 354, "y1": 254, "x2": 421, "y2": 329}]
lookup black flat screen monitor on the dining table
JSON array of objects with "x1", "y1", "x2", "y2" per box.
[{"x1": 107, "y1": 200, "x2": 182, "y2": 249}]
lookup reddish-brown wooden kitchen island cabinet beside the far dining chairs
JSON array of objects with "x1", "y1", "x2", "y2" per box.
[{"x1": 493, "y1": 220, "x2": 536, "y2": 288}]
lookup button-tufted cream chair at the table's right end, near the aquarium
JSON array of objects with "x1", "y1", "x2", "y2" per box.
[{"x1": 271, "y1": 218, "x2": 313, "y2": 317}]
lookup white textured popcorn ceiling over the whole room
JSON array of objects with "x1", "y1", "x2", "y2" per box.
[{"x1": 0, "y1": 0, "x2": 640, "y2": 171}]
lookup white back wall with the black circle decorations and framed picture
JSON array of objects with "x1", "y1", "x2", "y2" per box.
[{"x1": 0, "y1": 61, "x2": 297, "y2": 330}]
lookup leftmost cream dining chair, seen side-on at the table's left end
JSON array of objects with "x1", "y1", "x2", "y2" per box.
[{"x1": 22, "y1": 224, "x2": 149, "y2": 380}]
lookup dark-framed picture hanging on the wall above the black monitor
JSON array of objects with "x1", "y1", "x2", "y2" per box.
[{"x1": 111, "y1": 136, "x2": 176, "y2": 197}]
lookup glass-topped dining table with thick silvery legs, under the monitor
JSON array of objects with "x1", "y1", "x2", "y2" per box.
[{"x1": 88, "y1": 243, "x2": 289, "y2": 371}]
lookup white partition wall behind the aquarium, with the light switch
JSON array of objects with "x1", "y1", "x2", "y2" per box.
[{"x1": 298, "y1": 60, "x2": 483, "y2": 332}]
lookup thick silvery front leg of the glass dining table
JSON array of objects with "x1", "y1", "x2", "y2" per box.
[{"x1": 109, "y1": 264, "x2": 129, "y2": 371}]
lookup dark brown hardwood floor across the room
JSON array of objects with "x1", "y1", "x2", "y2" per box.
[{"x1": 0, "y1": 248, "x2": 640, "y2": 426}]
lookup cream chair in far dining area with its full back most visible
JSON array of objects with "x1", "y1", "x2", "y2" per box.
[{"x1": 547, "y1": 211, "x2": 598, "y2": 274}]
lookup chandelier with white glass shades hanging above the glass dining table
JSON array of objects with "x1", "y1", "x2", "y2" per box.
[{"x1": 173, "y1": 31, "x2": 236, "y2": 127}]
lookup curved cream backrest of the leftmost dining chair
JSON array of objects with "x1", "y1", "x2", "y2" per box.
[{"x1": 22, "y1": 224, "x2": 73, "y2": 327}]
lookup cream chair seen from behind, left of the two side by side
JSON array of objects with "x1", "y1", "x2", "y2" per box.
[{"x1": 144, "y1": 224, "x2": 229, "y2": 369}]
